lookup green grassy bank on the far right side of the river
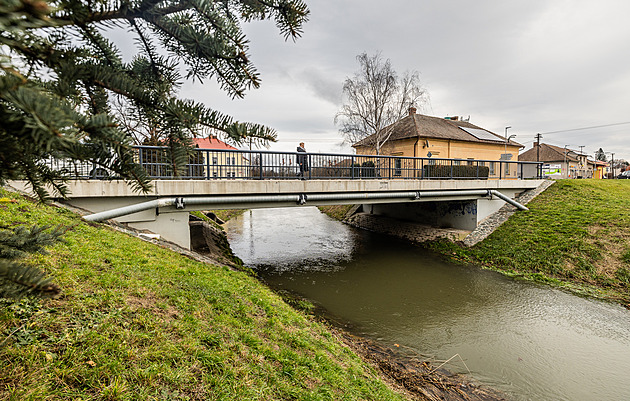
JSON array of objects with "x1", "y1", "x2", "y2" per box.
[{"x1": 429, "y1": 180, "x2": 630, "y2": 303}]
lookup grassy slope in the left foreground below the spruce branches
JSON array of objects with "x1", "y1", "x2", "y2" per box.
[{"x1": 0, "y1": 190, "x2": 402, "y2": 400}]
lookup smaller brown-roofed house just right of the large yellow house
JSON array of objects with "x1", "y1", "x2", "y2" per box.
[{"x1": 518, "y1": 143, "x2": 596, "y2": 178}]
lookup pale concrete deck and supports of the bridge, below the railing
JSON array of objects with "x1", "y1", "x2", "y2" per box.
[{"x1": 11, "y1": 180, "x2": 543, "y2": 248}]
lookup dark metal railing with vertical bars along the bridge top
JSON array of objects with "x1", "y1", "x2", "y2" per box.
[{"x1": 51, "y1": 146, "x2": 542, "y2": 180}]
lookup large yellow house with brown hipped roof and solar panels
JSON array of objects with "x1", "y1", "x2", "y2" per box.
[{"x1": 352, "y1": 107, "x2": 523, "y2": 177}]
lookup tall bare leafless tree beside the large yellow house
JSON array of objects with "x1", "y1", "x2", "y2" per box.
[{"x1": 335, "y1": 52, "x2": 429, "y2": 154}]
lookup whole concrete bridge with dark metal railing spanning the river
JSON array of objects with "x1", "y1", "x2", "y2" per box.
[{"x1": 11, "y1": 146, "x2": 542, "y2": 248}]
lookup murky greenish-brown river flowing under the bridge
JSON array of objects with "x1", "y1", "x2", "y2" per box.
[{"x1": 226, "y1": 207, "x2": 630, "y2": 401}]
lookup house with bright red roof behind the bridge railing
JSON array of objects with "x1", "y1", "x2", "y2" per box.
[{"x1": 190, "y1": 135, "x2": 250, "y2": 178}]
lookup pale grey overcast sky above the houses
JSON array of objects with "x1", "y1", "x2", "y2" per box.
[{"x1": 180, "y1": 0, "x2": 630, "y2": 160}]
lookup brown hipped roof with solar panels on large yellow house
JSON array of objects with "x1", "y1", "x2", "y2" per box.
[{"x1": 352, "y1": 108, "x2": 523, "y2": 147}]
